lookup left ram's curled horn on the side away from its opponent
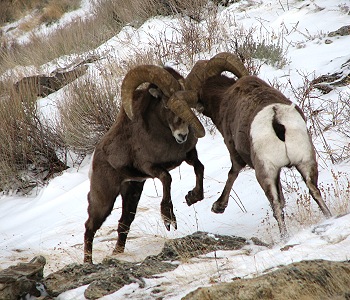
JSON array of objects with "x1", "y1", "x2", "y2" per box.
[{"x1": 121, "y1": 65, "x2": 181, "y2": 119}]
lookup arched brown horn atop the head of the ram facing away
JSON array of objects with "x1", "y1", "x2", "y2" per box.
[{"x1": 185, "y1": 52, "x2": 249, "y2": 90}]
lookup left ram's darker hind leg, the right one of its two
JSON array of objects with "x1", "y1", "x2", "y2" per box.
[{"x1": 113, "y1": 181, "x2": 145, "y2": 254}]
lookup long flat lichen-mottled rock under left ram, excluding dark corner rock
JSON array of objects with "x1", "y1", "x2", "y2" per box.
[{"x1": 43, "y1": 232, "x2": 247, "y2": 299}]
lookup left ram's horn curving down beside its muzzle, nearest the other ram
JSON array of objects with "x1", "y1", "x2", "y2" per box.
[{"x1": 167, "y1": 91, "x2": 205, "y2": 138}]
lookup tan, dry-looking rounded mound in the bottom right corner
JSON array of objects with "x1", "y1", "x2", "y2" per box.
[{"x1": 183, "y1": 260, "x2": 350, "y2": 300}]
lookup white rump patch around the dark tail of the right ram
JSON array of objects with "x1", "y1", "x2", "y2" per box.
[{"x1": 250, "y1": 103, "x2": 313, "y2": 169}]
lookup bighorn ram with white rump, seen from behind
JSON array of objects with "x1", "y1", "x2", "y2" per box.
[{"x1": 182, "y1": 53, "x2": 331, "y2": 237}]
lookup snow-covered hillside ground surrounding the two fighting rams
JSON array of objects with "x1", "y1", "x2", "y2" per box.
[{"x1": 0, "y1": 0, "x2": 350, "y2": 300}]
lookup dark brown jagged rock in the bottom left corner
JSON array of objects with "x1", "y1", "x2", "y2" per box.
[{"x1": 0, "y1": 256, "x2": 46, "y2": 300}]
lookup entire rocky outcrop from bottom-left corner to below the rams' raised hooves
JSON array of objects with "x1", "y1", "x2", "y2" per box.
[{"x1": 0, "y1": 232, "x2": 247, "y2": 300}]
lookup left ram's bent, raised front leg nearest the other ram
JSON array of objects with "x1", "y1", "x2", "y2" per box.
[{"x1": 185, "y1": 148, "x2": 204, "y2": 206}]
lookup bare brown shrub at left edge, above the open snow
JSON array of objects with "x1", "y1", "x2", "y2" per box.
[{"x1": 0, "y1": 83, "x2": 66, "y2": 193}]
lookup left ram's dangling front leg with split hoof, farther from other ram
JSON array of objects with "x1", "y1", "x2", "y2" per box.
[{"x1": 147, "y1": 166, "x2": 177, "y2": 231}]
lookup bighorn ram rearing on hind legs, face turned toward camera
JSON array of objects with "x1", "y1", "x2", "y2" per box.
[{"x1": 84, "y1": 65, "x2": 205, "y2": 263}]
